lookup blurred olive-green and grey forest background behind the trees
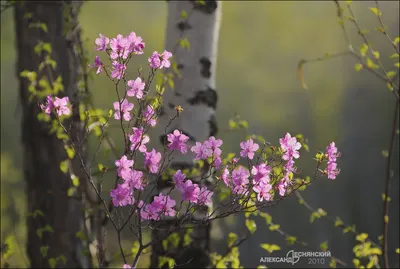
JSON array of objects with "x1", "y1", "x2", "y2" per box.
[{"x1": 1, "y1": 1, "x2": 399, "y2": 267}]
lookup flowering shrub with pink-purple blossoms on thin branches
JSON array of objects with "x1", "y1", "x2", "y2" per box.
[{"x1": 36, "y1": 32, "x2": 340, "y2": 268}]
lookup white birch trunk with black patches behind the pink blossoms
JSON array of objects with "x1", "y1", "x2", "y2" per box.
[{"x1": 152, "y1": 1, "x2": 221, "y2": 268}]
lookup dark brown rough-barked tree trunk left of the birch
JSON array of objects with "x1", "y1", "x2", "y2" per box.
[{"x1": 14, "y1": 1, "x2": 91, "y2": 268}]
